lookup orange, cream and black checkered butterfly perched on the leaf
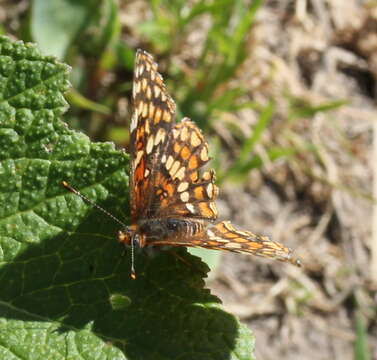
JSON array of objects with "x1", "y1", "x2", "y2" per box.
[{"x1": 114, "y1": 50, "x2": 300, "y2": 276}]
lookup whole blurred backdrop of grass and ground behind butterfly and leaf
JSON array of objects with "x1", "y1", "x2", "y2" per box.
[{"x1": 0, "y1": 0, "x2": 377, "y2": 360}]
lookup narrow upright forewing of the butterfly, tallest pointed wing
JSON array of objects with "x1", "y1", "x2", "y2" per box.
[{"x1": 130, "y1": 50, "x2": 176, "y2": 222}]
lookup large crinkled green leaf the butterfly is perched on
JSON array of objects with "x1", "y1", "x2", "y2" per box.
[{"x1": 0, "y1": 37, "x2": 254, "y2": 360}]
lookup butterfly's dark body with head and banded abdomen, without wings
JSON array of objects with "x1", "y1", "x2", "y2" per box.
[{"x1": 118, "y1": 218, "x2": 204, "y2": 247}]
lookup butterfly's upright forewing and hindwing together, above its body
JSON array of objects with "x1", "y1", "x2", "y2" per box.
[{"x1": 130, "y1": 50, "x2": 217, "y2": 223}]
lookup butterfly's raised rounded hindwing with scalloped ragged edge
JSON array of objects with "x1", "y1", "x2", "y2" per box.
[{"x1": 146, "y1": 118, "x2": 218, "y2": 220}]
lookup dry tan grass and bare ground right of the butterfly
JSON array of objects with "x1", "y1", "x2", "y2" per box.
[{"x1": 210, "y1": 0, "x2": 377, "y2": 360}]
